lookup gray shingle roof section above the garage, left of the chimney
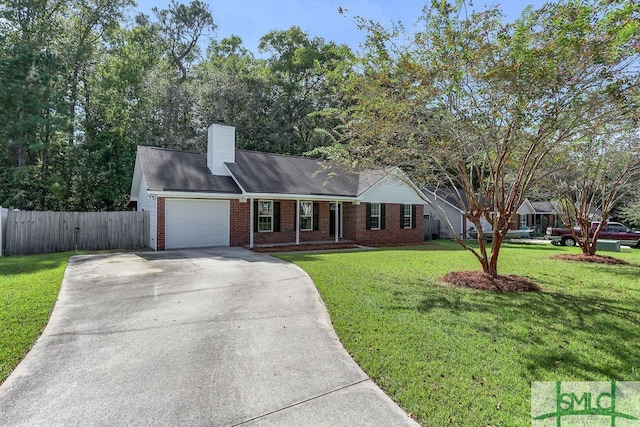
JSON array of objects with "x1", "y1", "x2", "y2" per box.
[{"x1": 138, "y1": 147, "x2": 241, "y2": 194}]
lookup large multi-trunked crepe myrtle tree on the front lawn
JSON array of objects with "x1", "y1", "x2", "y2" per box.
[{"x1": 325, "y1": 0, "x2": 639, "y2": 277}]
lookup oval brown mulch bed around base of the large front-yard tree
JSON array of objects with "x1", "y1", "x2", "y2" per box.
[{"x1": 444, "y1": 271, "x2": 540, "y2": 292}]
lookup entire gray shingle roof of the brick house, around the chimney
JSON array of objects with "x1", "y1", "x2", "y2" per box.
[{"x1": 138, "y1": 147, "x2": 388, "y2": 198}]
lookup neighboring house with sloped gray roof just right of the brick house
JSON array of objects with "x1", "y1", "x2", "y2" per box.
[{"x1": 422, "y1": 187, "x2": 471, "y2": 239}]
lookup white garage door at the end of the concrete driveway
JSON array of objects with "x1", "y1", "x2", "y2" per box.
[{"x1": 165, "y1": 199, "x2": 229, "y2": 249}]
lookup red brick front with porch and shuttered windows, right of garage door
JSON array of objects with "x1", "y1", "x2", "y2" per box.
[{"x1": 231, "y1": 198, "x2": 423, "y2": 250}]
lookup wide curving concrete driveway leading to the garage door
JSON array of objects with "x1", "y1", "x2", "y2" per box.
[{"x1": 0, "y1": 248, "x2": 416, "y2": 426}]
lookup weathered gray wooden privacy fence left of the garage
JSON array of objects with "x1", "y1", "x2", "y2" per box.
[{"x1": 3, "y1": 210, "x2": 149, "y2": 255}]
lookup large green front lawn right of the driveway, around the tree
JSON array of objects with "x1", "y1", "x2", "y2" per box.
[{"x1": 281, "y1": 242, "x2": 640, "y2": 426}]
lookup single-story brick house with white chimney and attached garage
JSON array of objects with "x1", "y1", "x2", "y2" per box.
[{"x1": 130, "y1": 125, "x2": 424, "y2": 250}]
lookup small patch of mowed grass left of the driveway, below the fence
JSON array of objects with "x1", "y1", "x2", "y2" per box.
[{"x1": 0, "y1": 253, "x2": 71, "y2": 383}]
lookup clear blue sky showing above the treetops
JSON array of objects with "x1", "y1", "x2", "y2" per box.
[{"x1": 138, "y1": 0, "x2": 544, "y2": 53}]
